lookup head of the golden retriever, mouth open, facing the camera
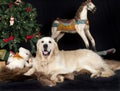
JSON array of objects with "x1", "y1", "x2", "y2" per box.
[{"x1": 37, "y1": 37, "x2": 58, "y2": 57}]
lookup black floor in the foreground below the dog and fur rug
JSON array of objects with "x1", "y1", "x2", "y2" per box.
[{"x1": 0, "y1": 71, "x2": 120, "y2": 91}]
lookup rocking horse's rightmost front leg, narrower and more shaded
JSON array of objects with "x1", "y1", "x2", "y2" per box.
[{"x1": 85, "y1": 26, "x2": 96, "y2": 51}]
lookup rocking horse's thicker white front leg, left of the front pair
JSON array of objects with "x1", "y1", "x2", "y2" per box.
[{"x1": 76, "y1": 25, "x2": 89, "y2": 49}]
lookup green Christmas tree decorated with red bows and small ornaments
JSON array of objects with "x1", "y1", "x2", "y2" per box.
[{"x1": 0, "y1": 0, "x2": 40, "y2": 52}]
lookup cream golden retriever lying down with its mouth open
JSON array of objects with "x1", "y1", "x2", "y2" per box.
[{"x1": 25, "y1": 37, "x2": 114, "y2": 82}]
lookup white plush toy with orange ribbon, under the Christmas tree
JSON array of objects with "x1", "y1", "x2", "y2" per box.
[{"x1": 6, "y1": 47, "x2": 32, "y2": 69}]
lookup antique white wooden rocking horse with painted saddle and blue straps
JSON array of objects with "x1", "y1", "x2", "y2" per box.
[{"x1": 51, "y1": 0, "x2": 96, "y2": 50}]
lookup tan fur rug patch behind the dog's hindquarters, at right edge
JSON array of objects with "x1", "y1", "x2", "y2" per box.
[{"x1": 105, "y1": 59, "x2": 120, "y2": 71}]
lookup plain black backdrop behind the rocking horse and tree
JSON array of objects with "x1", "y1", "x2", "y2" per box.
[{"x1": 26, "y1": 0, "x2": 120, "y2": 59}]
